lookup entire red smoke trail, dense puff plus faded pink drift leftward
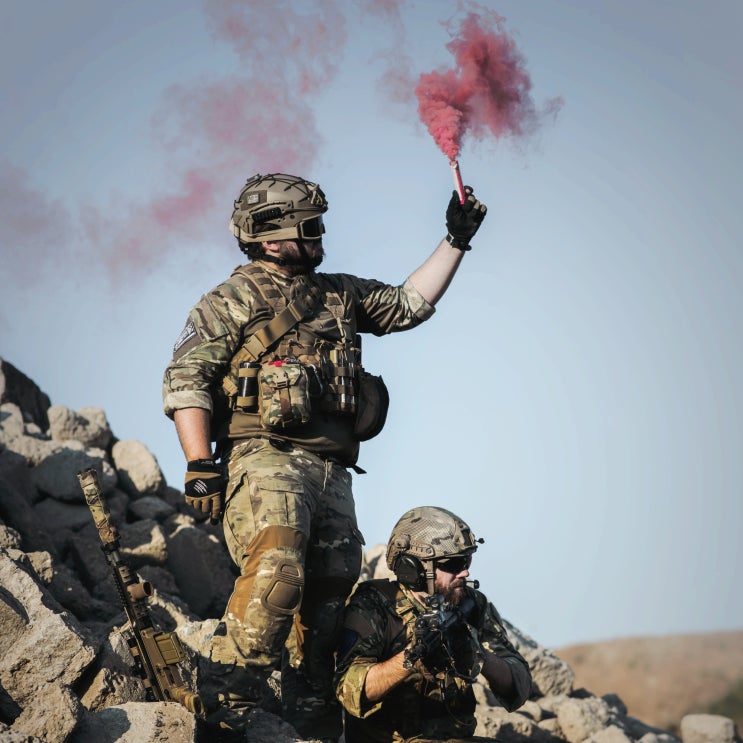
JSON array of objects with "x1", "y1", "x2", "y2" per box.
[{"x1": 7, "y1": 0, "x2": 560, "y2": 288}]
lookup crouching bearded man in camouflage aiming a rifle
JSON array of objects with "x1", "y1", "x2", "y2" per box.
[{"x1": 335, "y1": 506, "x2": 531, "y2": 743}]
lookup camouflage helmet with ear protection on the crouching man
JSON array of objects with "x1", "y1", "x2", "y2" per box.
[{"x1": 387, "y1": 506, "x2": 483, "y2": 593}]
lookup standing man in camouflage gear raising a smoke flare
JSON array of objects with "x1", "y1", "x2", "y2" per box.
[{"x1": 163, "y1": 173, "x2": 486, "y2": 740}]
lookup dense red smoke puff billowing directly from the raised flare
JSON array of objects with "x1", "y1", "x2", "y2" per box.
[{"x1": 415, "y1": 11, "x2": 562, "y2": 160}]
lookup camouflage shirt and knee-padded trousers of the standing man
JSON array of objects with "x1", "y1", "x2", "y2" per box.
[{"x1": 163, "y1": 263, "x2": 434, "y2": 738}]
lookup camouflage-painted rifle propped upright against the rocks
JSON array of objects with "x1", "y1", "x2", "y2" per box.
[{"x1": 77, "y1": 467, "x2": 204, "y2": 717}]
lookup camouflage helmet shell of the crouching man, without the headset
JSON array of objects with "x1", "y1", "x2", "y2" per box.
[{"x1": 387, "y1": 506, "x2": 477, "y2": 570}]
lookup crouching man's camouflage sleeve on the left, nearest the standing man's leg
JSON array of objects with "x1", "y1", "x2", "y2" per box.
[{"x1": 334, "y1": 583, "x2": 407, "y2": 718}]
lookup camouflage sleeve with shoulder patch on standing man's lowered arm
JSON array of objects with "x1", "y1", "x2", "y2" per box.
[{"x1": 163, "y1": 282, "x2": 255, "y2": 418}]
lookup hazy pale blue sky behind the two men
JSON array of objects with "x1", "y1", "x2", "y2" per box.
[{"x1": 0, "y1": 0, "x2": 743, "y2": 648}]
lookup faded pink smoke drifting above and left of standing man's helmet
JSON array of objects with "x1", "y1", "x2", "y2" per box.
[{"x1": 88, "y1": 0, "x2": 346, "y2": 278}]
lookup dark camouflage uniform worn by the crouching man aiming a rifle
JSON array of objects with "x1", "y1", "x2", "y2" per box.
[{"x1": 334, "y1": 580, "x2": 531, "y2": 743}]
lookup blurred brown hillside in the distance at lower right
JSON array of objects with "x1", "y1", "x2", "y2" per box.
[{"x1": 557, "y1": 631, "x2": 743, "y2": 734}]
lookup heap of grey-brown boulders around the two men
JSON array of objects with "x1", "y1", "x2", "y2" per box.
[{"x1": 0, "y1": 359, "x2": 736, "y2": 743}]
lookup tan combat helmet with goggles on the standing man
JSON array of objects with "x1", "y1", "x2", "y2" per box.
[{"x1": 230, "y1": 173, "x2": 328, "y2": 243}]
